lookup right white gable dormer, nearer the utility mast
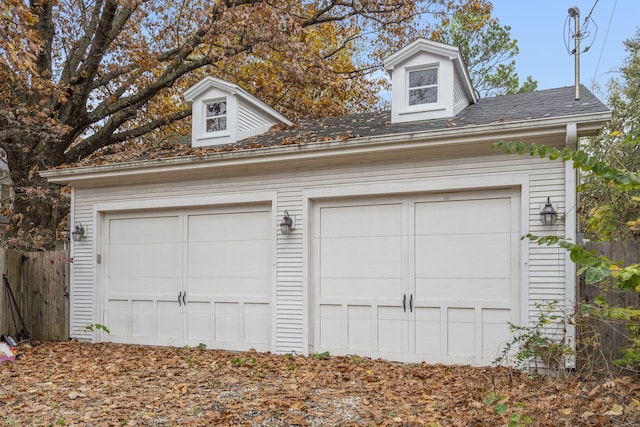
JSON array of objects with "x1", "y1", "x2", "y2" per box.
[{"x1": 384, "y1": 39, "x2": 477, "y2": 123}]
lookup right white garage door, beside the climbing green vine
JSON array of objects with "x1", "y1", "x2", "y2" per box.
[{"x1": 312, "y1": 190, "x2": 520, "y2": 364}]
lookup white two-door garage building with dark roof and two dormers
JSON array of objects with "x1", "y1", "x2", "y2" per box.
[{"x1": 42, "y1": 40, "x2": 610, "y2": 364}]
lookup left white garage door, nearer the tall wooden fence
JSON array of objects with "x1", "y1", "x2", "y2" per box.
[{"x1": 103, "y1": 207, "x2": 273, "y2": 350}]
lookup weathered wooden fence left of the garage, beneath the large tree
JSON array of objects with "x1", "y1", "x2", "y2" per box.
[{"x1": 0, "y1": 249, "x2": 69, "y2": 340}]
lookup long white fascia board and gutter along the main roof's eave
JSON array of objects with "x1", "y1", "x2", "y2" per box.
[{"x1": 40, "y1": 112, "x2": 611, "y2": 186}]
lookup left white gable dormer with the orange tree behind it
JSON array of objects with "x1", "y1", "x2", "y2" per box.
[{"x1": 184, "y1": 77, "x2": 293, "y2": 147}]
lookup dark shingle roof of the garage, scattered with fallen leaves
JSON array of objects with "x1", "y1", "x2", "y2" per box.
[{"x1": 76, "y1": 86, "x2": 609, "y2": 165}]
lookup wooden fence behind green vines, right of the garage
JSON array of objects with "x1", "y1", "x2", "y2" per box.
[{"x1": 578, "y1": 241, "x2": 640, "y2": 369}]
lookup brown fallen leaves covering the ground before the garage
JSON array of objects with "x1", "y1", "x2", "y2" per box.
[{"x1": 0, "y1": 341, "x2": 640, "y2": 426}]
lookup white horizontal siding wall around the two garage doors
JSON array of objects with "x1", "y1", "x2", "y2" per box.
[{"x1": 71, "y1": 150, "x2": 573, "y2": 353}]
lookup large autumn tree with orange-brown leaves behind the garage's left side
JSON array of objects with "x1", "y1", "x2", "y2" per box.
[{"x1": 0, "y1": 0, "x2": 486, "y2": 248}]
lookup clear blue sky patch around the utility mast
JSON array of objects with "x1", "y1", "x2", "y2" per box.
[{"x1": 491, "y1": 0, "x2": 640, "y2": 99}]
